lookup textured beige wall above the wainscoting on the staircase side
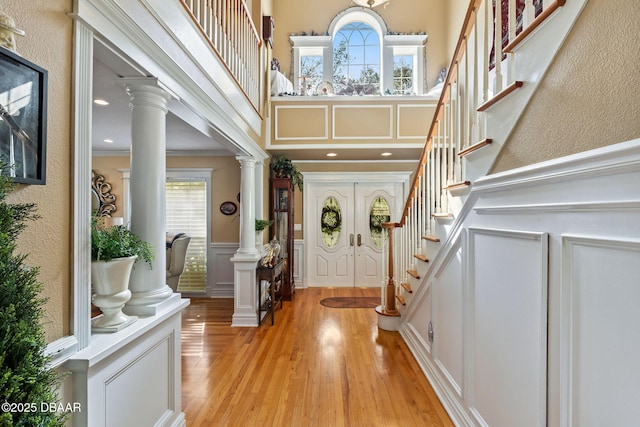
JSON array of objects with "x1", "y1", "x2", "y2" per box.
[{"x1": 494, "y1": 0, "x2": 640, "y2": 172}]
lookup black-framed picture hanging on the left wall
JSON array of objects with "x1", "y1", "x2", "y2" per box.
[{"x1": 0, "y1": 47, "x2": 48, "y2": 185}]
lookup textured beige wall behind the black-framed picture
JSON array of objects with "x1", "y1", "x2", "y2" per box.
[{"x1": 2, "y1": 0, "x2": 73, "y2": 341}]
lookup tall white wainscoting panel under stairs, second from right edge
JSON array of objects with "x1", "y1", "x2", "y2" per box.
[{"x1": 465, "y1": 228, "x2": 548, "y2": 427}]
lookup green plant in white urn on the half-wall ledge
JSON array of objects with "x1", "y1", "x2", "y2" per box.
[{"x1": 91, "y1": 218, "x2": 154, "y2": 332}]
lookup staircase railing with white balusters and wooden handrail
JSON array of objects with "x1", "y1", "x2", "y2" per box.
[{"x1": 382, "y1": 0, "x2": 565, "y2": 314}]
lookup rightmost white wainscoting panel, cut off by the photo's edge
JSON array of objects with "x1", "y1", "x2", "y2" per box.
[{"x1": 561, "y1": 235, "x2": 640, "y2": 427}]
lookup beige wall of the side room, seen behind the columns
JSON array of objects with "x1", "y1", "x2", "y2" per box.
[{"x1": 92, "y1": 156, "x2": 244, "y2": 243}]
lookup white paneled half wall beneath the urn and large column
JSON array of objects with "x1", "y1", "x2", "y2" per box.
[{"x1": 63, "y1": 294, "x2": 189, "y2": 427}]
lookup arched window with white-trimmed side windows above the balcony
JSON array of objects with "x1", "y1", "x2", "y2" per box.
[{"x1": 289, "y1": 7, "x2": 427, "y2": 95}]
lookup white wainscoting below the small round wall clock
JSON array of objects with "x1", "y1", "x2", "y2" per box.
[{"x1": 207, "y1": 243, "x2": 239, "y2": 298}]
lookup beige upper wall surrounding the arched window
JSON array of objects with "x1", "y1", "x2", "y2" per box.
[{"x1": 273, "y1": 0, "x2": 450, "y2": 86}]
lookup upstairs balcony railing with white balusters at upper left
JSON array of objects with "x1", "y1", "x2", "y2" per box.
[{"x1": 181, "y1": 0, "x2": 262, "y2": 111}]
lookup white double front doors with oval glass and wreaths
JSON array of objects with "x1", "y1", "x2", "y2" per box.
[{"x1": 304, "y1": 175, "x2": 406, "y2": 287}]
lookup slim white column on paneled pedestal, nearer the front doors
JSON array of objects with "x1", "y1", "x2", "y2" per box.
[{"x1": 231, "y1": 156, "x2": 260, "y2": 327}]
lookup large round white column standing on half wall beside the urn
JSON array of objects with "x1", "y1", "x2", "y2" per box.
[{"x1": 121, "y1": 78, "x2": 173, "y2": 316}]
